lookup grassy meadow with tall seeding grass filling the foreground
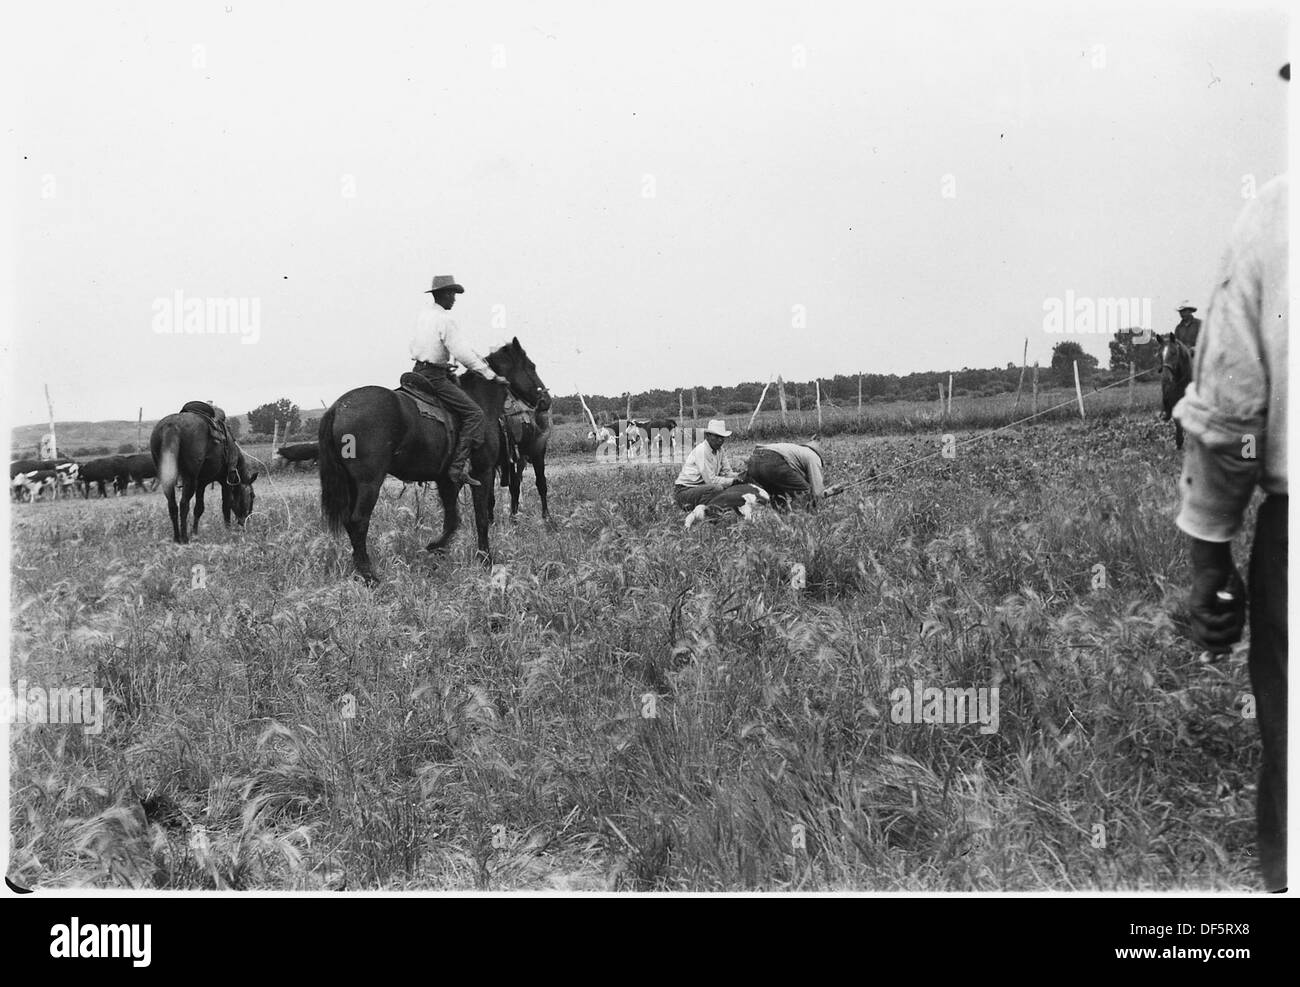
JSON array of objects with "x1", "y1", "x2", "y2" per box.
[{"x1": 9, "y1": 410, "x2": 1258, "y2": 891}]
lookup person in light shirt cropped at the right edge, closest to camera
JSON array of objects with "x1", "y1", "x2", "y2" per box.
[{"x1": 1174, "y1": 163, "x2": 1290, "y2": 891}]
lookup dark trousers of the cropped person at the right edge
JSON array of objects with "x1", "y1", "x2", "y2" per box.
[{"x1": 1251, "y1": 497, "x2": 1287, "y2": 891}]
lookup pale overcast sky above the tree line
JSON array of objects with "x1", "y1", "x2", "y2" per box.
[{"x1": 4, "y1": 0, "x2": 1288, "y2": 424}]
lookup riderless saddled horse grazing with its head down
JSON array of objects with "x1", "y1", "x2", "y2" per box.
[{"x1": 149, "y1": 411, "x2": 257, "y2": 545}]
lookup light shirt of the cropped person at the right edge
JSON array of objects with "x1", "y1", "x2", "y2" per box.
[{"x1": 1174, "y1": 182, "x2": 1287, "y2": 542}]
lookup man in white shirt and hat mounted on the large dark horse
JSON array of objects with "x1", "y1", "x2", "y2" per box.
[{"x1": 411, "y1": 274, "x2": 501, "y2": 486}]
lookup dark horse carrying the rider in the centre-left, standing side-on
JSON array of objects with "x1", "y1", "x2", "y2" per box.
[{"x1": 320, "y1": 339, "x2": 546, "y2": 580}]
